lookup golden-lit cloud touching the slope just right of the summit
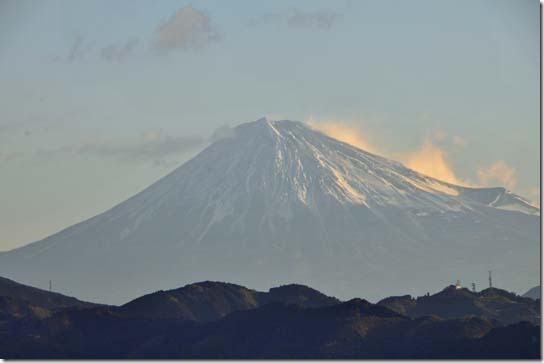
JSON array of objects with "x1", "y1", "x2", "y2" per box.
[{"x1": 307, "y1": 118, "x2": 380, "y2": 154}]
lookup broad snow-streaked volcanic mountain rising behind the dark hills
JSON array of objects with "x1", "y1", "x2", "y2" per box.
[{"x1": 0, "y1": 119, "x2": 540, "y2": 304}]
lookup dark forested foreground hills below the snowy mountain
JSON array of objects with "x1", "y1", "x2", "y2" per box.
[{"x1": 0, "y1": 281, "x2": 540, "y2": 359}]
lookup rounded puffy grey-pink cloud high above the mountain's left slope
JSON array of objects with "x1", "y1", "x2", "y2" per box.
[{"x1": 152, "y1": 5, "x2": 221, "y2": 53}]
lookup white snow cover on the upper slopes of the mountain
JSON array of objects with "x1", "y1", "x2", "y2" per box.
[{"x1": 102, "y1": 119, "x2": 538, "y2": 238}]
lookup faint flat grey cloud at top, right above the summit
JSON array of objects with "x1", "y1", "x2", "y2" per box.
[{"x1": 249, "y1": 8, "x2": 342, "y2": 30}]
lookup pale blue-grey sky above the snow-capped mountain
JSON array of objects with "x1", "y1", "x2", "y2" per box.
[{"x1": 0, "y1": 0, "x2": 540, "y2": 250}]
